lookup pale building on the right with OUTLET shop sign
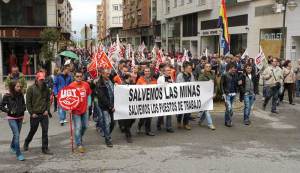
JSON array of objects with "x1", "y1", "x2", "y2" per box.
[{"x1": 157, "y1": 0, "x2": 300, "y2": 60}]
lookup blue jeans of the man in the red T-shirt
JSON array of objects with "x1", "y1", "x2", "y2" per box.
[{"x1": 72, "y1": 113, "x2": 89, "y2": 146}]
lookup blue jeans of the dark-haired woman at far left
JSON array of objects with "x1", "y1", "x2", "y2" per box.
[{"x1": 8, "y1": 119, "x2": 23, "y2": 156}]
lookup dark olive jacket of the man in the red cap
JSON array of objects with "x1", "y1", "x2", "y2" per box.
[{"x1": 26, "y1": 84, "x2": 50, "y2": 115}]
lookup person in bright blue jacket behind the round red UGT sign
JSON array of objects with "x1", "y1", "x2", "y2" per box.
[{"x1": 53, "y1": 65, "x2": 72, "y2": 126}]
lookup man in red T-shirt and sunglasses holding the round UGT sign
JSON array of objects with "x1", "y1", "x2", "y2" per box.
[{"x1": 69, "y1": 71, "x2": 92, "y2": 153}]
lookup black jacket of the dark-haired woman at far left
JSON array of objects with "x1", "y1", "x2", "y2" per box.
[{"x1": 0, "y1": 93, "x2": 26, "y2": 118}]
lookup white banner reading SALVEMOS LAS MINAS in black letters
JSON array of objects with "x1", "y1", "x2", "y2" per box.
[{"x1": 114, "y1": 81, "x2": 214, "y2": 120}]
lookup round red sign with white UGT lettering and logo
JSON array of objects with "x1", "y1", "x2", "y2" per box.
[{"x1": 57, "y1": 86, "x2": 80, "y2": 110}]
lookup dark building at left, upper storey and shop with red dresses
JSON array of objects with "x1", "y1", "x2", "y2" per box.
[{"x1": 0, "y1": 0, "x2": 58, "y2": 80}]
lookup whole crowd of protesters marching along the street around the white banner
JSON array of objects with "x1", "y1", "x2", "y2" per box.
[{"x1": 0, "y1": 45, "x2": 300, "y2": 160}]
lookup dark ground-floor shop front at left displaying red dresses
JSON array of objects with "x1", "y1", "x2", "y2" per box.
[{"x1": 0, "y1": 27, "x2": 47, "y2": 79}]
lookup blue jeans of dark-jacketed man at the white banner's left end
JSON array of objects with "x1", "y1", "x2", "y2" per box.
[{"x1": 95, "y1": 105, "x2": 114, "y2": 141}]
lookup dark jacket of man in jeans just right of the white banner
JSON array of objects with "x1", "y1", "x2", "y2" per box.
[{"x1": 220, "y1": 73, "x2": 239, "y2": 95}]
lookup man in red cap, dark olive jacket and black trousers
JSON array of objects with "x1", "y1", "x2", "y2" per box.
[{"x1": 24, "y1": 72, "x2": 52, "y2": 154}]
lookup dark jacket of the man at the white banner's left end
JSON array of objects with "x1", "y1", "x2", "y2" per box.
[{"x1": 96, "y1": 78, "x2": 114, "y2": 112}]
